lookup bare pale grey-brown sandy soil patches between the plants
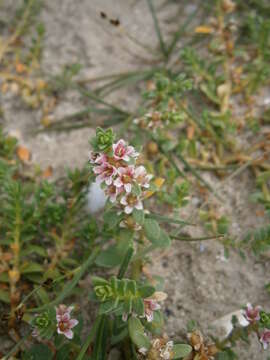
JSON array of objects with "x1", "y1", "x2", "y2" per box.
[{"x1": 0, "y1": 0, "x2": 270, "y2": 360}]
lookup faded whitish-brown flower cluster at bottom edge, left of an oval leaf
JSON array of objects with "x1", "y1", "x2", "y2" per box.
[{"x1": 139, "y1": 338, "x2": 173, "y2": 360}]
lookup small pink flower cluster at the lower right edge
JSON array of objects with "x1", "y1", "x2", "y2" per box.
[{"x1": 244, "y1": 303, "x2": 270, "y2": 350}]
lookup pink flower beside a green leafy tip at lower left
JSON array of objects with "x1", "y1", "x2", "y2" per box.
[{"x1": 56, "y1": 304, "x2": 79, "y2": 339}]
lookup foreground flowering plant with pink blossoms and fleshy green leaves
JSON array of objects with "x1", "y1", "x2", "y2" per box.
[{"x1": 1, "y1": 128, "x2": 270, "y2": 360}]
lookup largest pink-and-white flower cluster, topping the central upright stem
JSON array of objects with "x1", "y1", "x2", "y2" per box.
[{"x1": 90, "y1": 139, "x2": 152, "y2": 214}]
